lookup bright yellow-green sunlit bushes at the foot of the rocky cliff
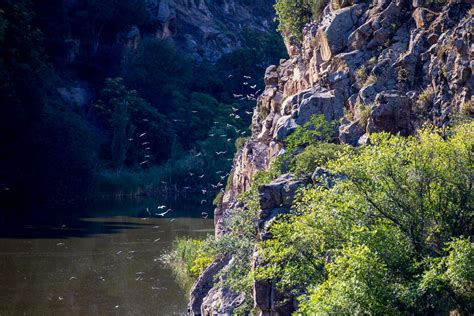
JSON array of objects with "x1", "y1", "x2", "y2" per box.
[{"x1": 174, "y1": 119, "x2": 474, "y2": 315}]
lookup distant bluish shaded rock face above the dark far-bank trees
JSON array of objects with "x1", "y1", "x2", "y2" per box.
[{"x1": 147, "y1": 0, "x2": 274, "y2": 61}]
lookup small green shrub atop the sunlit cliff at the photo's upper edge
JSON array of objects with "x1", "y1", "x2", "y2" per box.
[{"x1": 275, "y1": 0, "x2": 324, "y2": 39}]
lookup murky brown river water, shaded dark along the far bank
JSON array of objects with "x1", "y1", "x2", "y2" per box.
[{"x1": 0, "y1": 196, "x2": 213, "y2": 316}]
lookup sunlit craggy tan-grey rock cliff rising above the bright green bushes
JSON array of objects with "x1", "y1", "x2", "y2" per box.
[{"x1": 190, "y1": 0, "x2": 474, "y2": 315}]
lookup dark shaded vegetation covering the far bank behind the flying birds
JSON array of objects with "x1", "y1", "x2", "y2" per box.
[{"x1": 0, "y1": 0, "x2": 284, "y2": 210}]
